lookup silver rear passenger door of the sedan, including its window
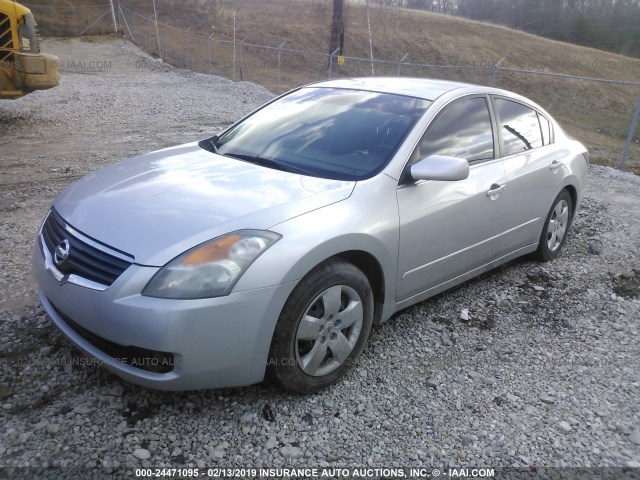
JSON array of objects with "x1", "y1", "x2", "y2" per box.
[{"x1": 492, "y1": 96, "x2": 566, "y2": 252}]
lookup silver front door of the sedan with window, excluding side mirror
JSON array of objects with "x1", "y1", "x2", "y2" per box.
[{"x1": 396, "y1": 96, "x2": 506, "y2": 301}]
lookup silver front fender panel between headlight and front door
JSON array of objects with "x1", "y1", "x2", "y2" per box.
[{"x1": 234, "y1": 175, "x2": 399, "y2": 316}]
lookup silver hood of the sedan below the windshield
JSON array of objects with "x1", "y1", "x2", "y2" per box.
[{"x1": 54, "y1": 143, "x2": 355, "y2": 266}]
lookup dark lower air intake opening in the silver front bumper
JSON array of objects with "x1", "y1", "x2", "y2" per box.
[{"x1": 51, "y1": 304, "x2": 175, "y2": 373}]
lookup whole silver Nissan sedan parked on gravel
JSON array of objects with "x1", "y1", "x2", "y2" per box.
[{"x1": 33, "y1": 78, "x2": 589, "y2": 393}]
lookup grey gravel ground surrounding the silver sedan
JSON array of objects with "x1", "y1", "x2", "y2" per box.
[{"x1": 0, "y1": 39, "x2": 640, "y2": 478}]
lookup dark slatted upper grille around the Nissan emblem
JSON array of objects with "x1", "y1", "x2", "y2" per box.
[{"x1": 42, "y1": 209, "x2": 133, "y2": 286}]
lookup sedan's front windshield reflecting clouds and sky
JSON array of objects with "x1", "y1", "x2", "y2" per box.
[{"x1": 200, "y1": 88, "x2": 431, "y2": 180}]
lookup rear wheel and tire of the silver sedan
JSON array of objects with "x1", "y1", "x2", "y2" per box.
[{"x1": 536, "y1": 190, "x2": 573, "y2": 262}]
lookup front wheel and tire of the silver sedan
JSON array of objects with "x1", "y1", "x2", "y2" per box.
[{"x1": 267, "y1": 260, "x2": 373, "y2": 393}]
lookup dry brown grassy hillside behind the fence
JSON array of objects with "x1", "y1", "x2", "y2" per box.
[{"x1": 28, "y1": 0, "x2": 640, "y2": 172}]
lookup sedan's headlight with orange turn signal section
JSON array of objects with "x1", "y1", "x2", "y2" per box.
[{"x1": 142, "y1": 230, "x2": 281, "y2": 299}]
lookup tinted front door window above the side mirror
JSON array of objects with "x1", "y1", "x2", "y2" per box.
[{"x1": 411, "y1": 98, "x2": 494, "y2": 163}]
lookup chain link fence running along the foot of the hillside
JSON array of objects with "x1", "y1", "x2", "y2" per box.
[{"x1": 26, "y1": 1, "x2": 640, "y2": 174}]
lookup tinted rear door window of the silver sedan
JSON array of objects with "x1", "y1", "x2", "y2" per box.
[{"x1": 496, "y1": 98, "x2": 542, "y2": 156}]
